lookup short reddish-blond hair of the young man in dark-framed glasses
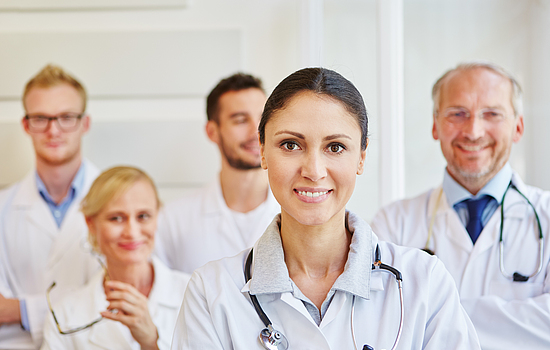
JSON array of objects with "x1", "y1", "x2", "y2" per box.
[{"x1": 23, "y1": 64, "x2": 87, "y2": 112}]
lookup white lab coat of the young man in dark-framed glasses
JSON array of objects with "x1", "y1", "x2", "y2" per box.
[{"x1": 0, "y1": 161, "x2": 99, "y2": 349}]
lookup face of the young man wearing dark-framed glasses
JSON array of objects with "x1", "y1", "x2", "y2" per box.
[{"x1": 22, "y1": 84, "x2": 90, "y2": 165}]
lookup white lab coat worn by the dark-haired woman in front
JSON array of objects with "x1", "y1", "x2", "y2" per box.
[{"x1": 172, "y1": 213, "x2": 479, "y2": 350}]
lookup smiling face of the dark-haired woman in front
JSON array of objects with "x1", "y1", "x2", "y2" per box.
[{"x1": 261, "y1": 91, "x2": 366, "y2": 225}]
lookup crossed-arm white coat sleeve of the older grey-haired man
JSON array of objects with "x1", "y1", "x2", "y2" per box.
[{"x1": 462, "y1": 282, "x2": 550, "y2": 350}]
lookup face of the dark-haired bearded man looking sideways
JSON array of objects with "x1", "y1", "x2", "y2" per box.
[{"x1": 206, "y1": 88, "x2": 266, "y2": 170}]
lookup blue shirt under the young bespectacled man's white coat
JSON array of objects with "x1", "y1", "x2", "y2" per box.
[{"x1": 19, "y1": 162, "x2": 86, "y2": 331}]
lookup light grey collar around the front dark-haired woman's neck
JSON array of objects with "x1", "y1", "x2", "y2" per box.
[{"x1": 246, "y1": 212, "x2": 381, "y2": 299}]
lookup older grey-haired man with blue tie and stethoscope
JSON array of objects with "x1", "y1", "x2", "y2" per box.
[{"x1": 372, "y1": 62, "x2": 550, "y2": 350}]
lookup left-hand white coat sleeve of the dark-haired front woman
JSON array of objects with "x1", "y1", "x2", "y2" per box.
[{"x1": 171, "y1": 272, "x2": 224, "y2": 350}]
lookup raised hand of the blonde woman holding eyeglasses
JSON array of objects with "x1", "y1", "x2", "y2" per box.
[{"x1": 101, "y1": 281, "x2": 158, "y2": 349}]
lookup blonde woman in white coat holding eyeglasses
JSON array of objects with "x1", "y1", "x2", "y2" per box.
[{"x1": 42, "y1": 167, "x2": 189, "y2": 349}]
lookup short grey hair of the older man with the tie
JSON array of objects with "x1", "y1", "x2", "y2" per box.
[{"x1": 432, "y1": 61, "x2": 523, "y2": 116}]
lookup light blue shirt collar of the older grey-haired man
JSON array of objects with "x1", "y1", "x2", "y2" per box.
[{"x1": 442, "y1": 163, "x2": 513, "y2": 207}]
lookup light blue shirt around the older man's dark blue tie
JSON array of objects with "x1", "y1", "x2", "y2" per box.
[{"x1": 443, "y1": 163, "x2": 513, "y2": 227}]
